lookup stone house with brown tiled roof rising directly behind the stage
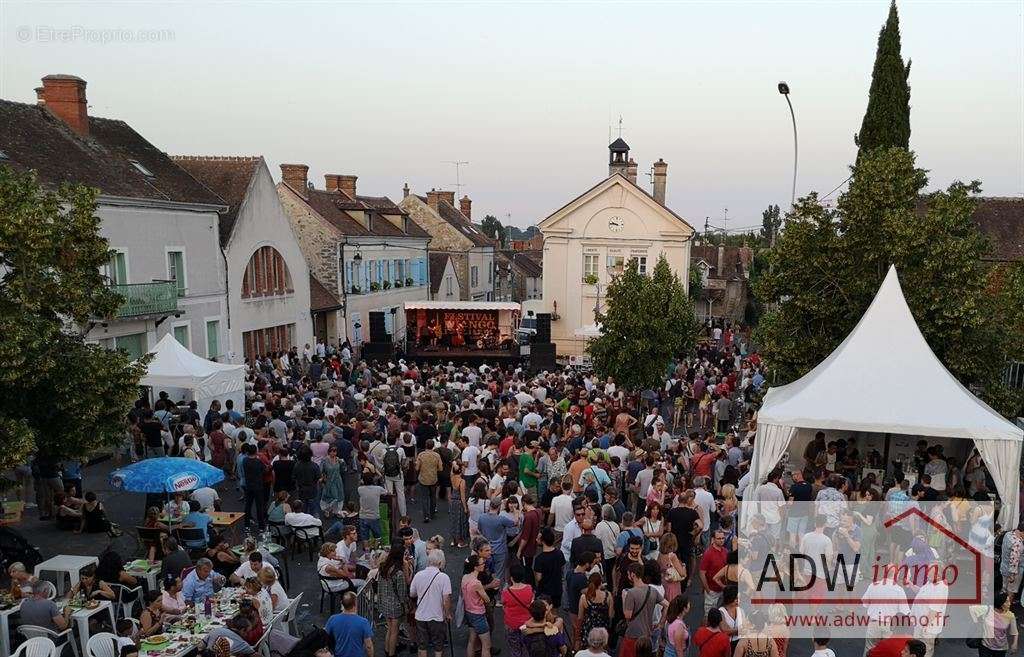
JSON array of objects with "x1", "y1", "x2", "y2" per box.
[{"x1": 399, "y1": 185, "x2": 497, "y2": 301}]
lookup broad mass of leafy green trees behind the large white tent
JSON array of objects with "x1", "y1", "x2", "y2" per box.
[{"x1": 756, "y1": 148, "x2": 1024, "y2": 412}]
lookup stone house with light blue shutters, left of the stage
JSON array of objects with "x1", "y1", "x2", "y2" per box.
[{"x1": 278, "y1": 164, "x2": 430, "y2": 345}]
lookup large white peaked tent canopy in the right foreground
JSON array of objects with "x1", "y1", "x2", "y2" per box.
[{"x1": 751, "y1": 267, "x2": 1024, "y2": 528}]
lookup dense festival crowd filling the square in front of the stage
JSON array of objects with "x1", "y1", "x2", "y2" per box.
[{"x1": 4, "y1": 327, "x2": 1024, "y2": 657}]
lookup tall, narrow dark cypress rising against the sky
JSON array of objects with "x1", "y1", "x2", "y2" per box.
[{"x1": 854, "y1": 0, "x2": 910, "y2": 153}]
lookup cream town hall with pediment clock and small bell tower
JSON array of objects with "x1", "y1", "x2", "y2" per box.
[{"x1": 539, "y1": 139, "x2": 693, "y2": 356}]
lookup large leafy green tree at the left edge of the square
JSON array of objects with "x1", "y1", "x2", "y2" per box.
[{"x1": 0, "y1": 162, "x2": 144, "y2": 471}]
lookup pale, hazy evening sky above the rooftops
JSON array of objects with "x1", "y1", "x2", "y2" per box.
[{"x1": 0, "y1": 0, "x2": 1024, "y2": 232}]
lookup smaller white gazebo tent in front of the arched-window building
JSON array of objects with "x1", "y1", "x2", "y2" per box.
[{"x1": 139, "y1": 334, "x2": 246, "y2": 417}]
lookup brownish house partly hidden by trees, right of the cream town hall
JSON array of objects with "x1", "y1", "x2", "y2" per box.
[{"x1": 690, "y1": 245, "x2": 754, "y2": 322}]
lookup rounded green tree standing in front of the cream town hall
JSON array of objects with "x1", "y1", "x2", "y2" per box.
[{"x1": 587, "y1": 255, "x2": 696, "y2": 390}]
